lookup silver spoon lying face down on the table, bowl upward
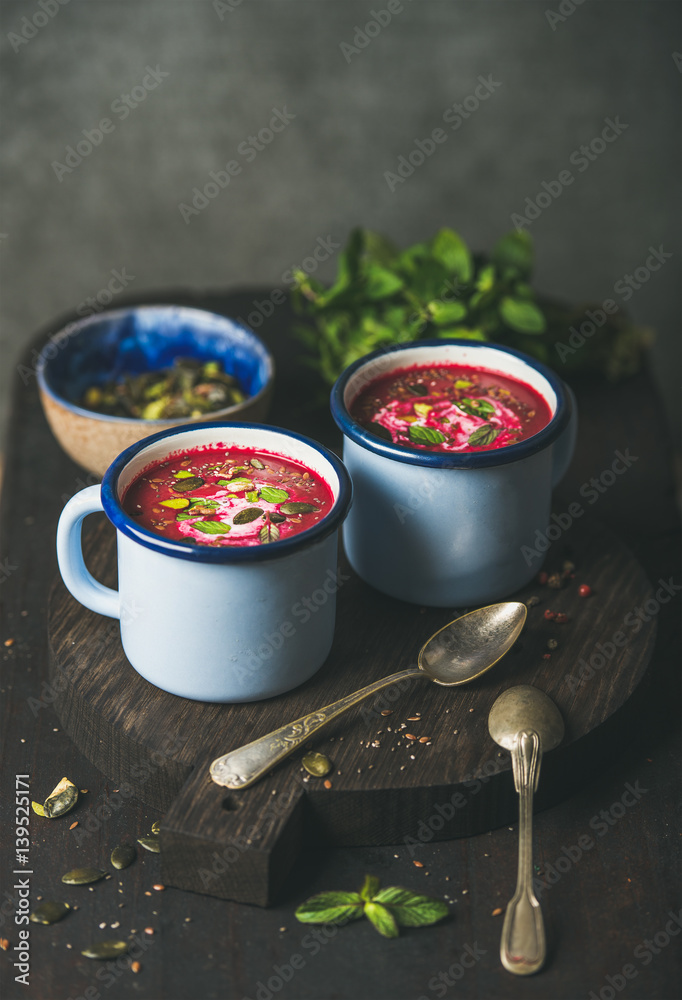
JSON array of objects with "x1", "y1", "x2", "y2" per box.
[{"x1": 488, "y1": 684, "x2": 564, "y2": 976}]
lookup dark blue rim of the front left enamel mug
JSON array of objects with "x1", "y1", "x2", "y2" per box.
[{"x1": 101, "y1": 421, "x2": 353, "y2": 563}]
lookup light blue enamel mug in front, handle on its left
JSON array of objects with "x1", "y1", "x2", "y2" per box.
[{"x1": 57, "y1": 423, "x2": 352, "y2": 702}]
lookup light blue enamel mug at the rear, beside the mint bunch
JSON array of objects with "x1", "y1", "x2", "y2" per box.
[{"x1": 331, "y1": 340, "x2": 577, "y2": 607}]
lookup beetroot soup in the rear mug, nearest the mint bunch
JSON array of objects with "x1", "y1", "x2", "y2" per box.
[{"x1": 349, "y1": 364, "x2": 552, "y2": 452}]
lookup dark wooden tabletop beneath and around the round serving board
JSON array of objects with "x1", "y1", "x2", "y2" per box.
[{"x1": 0, "y1": 289, "x2": 682, "y2": 1000}]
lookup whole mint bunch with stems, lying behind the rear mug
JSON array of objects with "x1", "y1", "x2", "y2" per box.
[{"x1": 291, "y1": 228, "x2": 652, "y2": 384}]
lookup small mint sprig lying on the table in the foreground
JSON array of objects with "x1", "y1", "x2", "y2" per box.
[{"x1": 296, "y1": 875, "x2": 450, "y2": 937}]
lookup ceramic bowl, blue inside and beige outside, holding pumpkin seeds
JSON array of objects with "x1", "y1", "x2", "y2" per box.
[{"x1": 36, "y1": 305, "x2": 275, "y2": 476}]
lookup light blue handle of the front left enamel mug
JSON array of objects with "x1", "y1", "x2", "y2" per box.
[{"x1": 57, "y1": 486, "x2": 121, "y2": 618}]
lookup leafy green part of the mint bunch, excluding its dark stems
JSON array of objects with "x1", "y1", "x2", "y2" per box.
[{"x1": 292, "y1": 229, "x2": 546, "y2": 383}]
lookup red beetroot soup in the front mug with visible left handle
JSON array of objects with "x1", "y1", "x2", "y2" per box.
[{"x1": 122, "y1": 446, "x2": 334, "y2": 546}]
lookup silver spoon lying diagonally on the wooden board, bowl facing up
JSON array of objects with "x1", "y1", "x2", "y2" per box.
[{"x1": 210, "y1": 601, "x2": 526, "y2": 788}]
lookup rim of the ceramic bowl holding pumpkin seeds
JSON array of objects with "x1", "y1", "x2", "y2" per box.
[{"x1": 35, "y1": 302, "x2": 275, "y2": 428}]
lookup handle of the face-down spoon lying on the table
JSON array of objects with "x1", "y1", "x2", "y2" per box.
[{"x1": 500, "y1": 731, "x2": 546, "y2": 976}]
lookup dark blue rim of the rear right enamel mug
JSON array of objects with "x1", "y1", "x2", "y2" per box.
[{"x1": 330, "y1": 338, "x2": 572, "y2": 469}]
